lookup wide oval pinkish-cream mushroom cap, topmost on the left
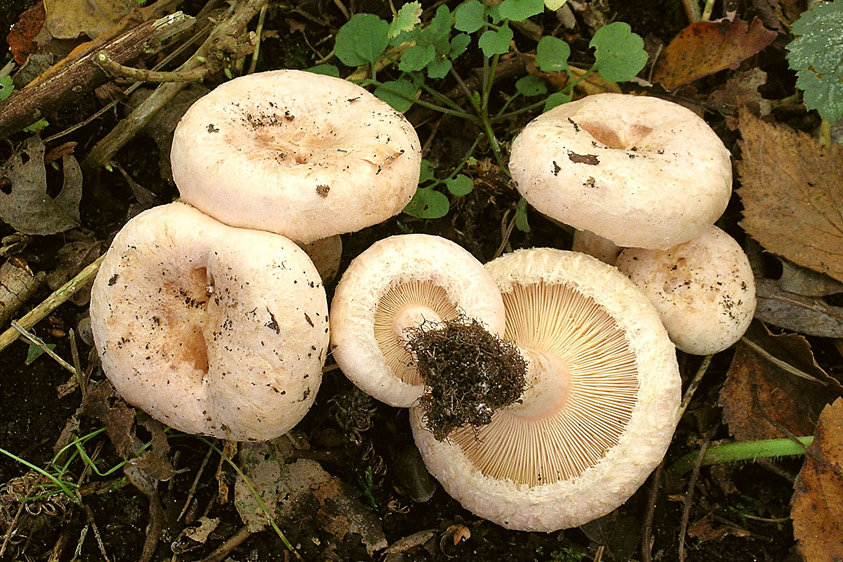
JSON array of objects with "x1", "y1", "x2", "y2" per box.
[{"x1": 170, "y1": 70, "x2": 421, "y2": 243}]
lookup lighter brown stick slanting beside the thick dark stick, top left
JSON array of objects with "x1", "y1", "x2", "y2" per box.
[{"x1": 82, "y1": 0, "x2": 267, "y2": 169}]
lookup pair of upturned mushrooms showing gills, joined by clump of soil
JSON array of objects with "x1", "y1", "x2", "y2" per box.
[{"x1": 331, "y1": 234, "x2": 680, "y2": 531}]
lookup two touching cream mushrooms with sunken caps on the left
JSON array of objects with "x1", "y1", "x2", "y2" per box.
[{"x1": 91, "y1": 70, "x2": 421, "y2": 440}]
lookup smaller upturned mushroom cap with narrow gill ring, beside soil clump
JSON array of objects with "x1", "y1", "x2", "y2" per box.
[{"x1": 331, "y1": 234, "x2": 505, "y2": 408}]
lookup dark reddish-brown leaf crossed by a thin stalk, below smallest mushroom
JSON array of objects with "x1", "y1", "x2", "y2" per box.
[{"x1": 719, "y1": 330, "x2": 835, "y2": 441}]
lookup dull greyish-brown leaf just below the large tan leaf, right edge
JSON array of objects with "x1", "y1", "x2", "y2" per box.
[{"x1": 755, "y1": 279, "x2": 843, "y2": 338}]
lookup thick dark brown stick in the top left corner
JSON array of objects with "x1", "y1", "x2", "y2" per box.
[{"x1": 0, "y1": 12, "x2": 192, "y2": 139}]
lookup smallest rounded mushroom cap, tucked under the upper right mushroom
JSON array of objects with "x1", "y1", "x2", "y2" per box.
[{"x1": 617, "y1": 225, "x2": 755, "y2": 355}]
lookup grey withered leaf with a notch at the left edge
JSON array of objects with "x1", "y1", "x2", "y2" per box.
[{"x1": 0, "y1": 136, "x2": 82, "y2": 235}]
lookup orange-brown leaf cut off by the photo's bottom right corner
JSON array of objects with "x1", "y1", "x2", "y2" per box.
[{"x1": 790, "y1": 398, "x2": 843, "y2": 562}]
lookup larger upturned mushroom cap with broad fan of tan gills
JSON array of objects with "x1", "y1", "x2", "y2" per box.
[{"x1": 411, "y1": 248, "x2": 680, "y2": 532}]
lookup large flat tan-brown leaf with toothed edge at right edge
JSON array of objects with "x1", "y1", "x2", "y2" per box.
[{"x1": 738, "y1": 111, "x2": 843, "y2": 281}]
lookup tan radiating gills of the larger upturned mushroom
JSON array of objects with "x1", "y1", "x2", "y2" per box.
[{"x1": 450, "y1": 283, "x2": 638, "y2": 486}]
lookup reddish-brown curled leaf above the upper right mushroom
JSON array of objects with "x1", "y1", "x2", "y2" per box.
[{"x1": 653, "y1": 18, "x2": 776, "y2": 90}]
